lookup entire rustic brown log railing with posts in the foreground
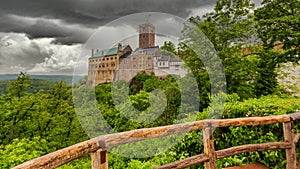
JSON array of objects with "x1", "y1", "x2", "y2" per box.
[{"x1": 13, "y1": 111, "x2": 300, "y2": 169}]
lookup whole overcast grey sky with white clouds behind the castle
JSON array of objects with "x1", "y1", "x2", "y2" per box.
[{"x1": 0, "y1": 0, "x2": 259, "y2": 74}]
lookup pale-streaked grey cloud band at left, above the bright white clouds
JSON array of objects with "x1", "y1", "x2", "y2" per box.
[{"x1": 0, "y1": 15, "x2": 94, "y2": 44}]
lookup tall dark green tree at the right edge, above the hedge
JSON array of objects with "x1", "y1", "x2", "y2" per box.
[{"x1": 255, "y1": 0, "x2": 300, "y2": 96}]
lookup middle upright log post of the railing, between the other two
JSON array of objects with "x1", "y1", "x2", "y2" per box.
[{"x1": 202, "y1": 125, "x2": 217, "y2": 169}]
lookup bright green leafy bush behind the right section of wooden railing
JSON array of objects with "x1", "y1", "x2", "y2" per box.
[{"x1": 166, "y1": 94, "x2": 300, "y2": 168}]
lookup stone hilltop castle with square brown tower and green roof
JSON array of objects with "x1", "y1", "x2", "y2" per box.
[{"x1": 86, "y1": 22, "x2": 185, "y2": 86}]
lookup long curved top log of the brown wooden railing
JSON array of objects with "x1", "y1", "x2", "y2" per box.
[{"x1": 14, "y1": 111, "x2": 300, "y2": 169}]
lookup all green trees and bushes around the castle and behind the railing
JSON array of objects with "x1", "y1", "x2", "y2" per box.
[{"x1": 0, "y1": 0, "x2": 300, "y2": 168}]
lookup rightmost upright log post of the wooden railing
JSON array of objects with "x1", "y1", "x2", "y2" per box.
[{"x1": 283, "y1": 122, "x2": 297, "y2": 169}]
